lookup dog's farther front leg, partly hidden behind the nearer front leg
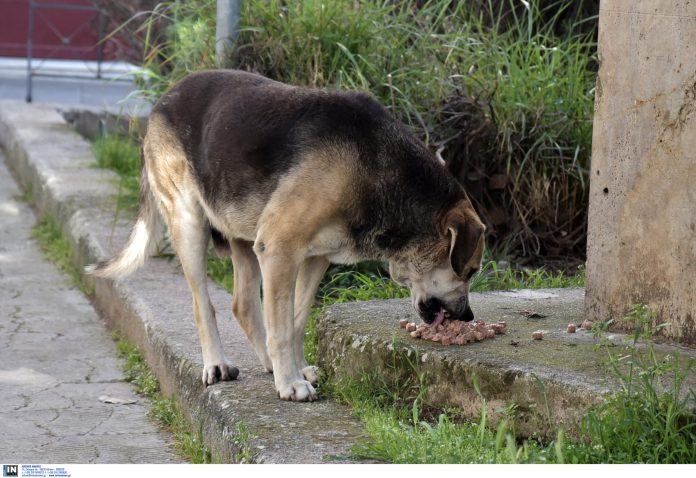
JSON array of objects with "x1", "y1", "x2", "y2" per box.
[{"x1": 294, "y1": 257, "x2": 329, "y2": 385}]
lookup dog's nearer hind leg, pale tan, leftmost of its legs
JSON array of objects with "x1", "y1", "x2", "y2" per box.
[{"x1": 168, "y1": 200, "x2": 239, "y2": 385}]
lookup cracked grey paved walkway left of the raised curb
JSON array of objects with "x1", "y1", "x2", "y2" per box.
[{"x1": 0, "y1": 153, "x2": 182, "y2": 463}]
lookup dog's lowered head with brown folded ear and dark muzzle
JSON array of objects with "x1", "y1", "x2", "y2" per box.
[{"x1": 389, "y1": 200, "x2": 485, "y2": 325}]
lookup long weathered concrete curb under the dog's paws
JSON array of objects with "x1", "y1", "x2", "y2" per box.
[{"x1": 0, "y1": 101, "x2": 363, "y2": 463}]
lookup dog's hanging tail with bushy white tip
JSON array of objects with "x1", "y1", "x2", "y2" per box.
[{"x1": 85, "y1": 151, "x2": 163, "y2": 279}]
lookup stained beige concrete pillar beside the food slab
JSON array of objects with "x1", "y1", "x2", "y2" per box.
[{"x1": 585, "y1": 0, "x2": 696, "y2": 345}]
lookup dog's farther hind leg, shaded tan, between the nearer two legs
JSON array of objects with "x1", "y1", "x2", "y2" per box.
[{"x1": 229, "y1": 240, "x2": 273, "y2": 372}]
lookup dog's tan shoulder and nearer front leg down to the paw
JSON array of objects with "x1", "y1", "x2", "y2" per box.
[{"x1": 254, "y1": 145, "x2": 353, "y2": 400}]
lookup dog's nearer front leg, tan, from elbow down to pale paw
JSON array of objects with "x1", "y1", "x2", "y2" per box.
[{"x1": 254, "y1": 239, "x2": 317, "y2": 401}]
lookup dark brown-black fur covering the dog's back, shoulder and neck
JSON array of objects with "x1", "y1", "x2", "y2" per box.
[{"x1": 153, "y1": 70, "x2": 465, "y2": 258}]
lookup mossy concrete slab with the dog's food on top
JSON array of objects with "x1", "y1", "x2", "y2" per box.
[{"x1": 317, "y1": 289, "x2": 696, "y2": 438}]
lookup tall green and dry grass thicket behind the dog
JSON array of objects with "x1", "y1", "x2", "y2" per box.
[{"x1": 129, "y1": 0, "x2": 596, "y2": 258}]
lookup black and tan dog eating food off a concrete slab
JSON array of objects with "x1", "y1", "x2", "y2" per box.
[{"x1": 88, "y1": 70, "x2": 485, "y2": 401}]
